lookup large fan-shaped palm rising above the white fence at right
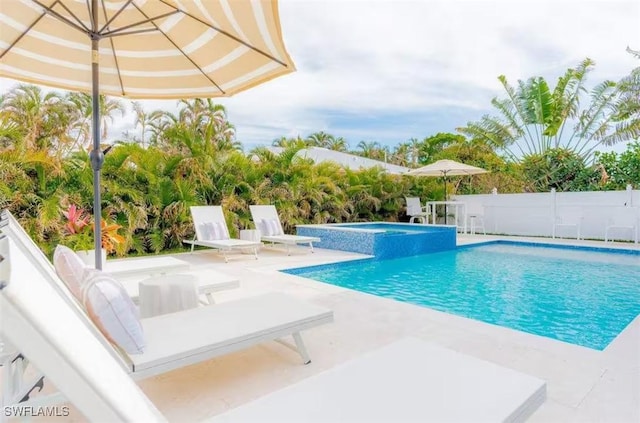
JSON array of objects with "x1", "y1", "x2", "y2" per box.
[{"x1": 458, "y1": 58, "x2": 634, "y2": 163}]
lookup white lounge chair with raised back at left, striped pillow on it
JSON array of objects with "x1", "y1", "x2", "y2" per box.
[{"x1": 0, "y1": 212, "x2": 333, "y2": 421}]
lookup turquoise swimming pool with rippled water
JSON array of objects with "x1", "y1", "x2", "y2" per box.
[{"x1": 285, "y1": 242, "x2": 640, "y2": 350}]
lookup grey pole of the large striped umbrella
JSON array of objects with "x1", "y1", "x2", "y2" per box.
[{"x1": 89, "y1": 0, "x2": 104, "y2": 270}]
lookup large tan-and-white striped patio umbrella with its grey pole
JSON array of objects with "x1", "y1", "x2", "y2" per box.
[{"x1": 0, "y1": 0, "x2": 295, "y2": 268}]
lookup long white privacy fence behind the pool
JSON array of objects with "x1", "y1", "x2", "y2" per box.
[{"x1": 455, "y1": 187, "x2": 640, "y2": 240}]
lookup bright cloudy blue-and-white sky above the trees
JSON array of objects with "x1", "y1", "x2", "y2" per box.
[{"x1": 0, "y1": 0, "x2": 640, "y2": 150}]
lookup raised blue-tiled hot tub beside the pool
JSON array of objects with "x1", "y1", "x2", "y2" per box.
[{"x1": 297, "y1": 222, "x2": 456, "y2": 259}]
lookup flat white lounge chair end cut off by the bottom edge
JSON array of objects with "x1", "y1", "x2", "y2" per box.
[{"x1": 209, "y1": 338, "x2": 546, "y2": 423}]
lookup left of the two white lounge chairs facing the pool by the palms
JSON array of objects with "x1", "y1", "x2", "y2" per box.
[{"x1": 182, "y1": 206, "x2": 262, "y2": 262}]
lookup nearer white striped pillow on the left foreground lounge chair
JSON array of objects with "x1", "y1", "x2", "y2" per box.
[{"x1": 79, "y1": 269, "x2": 145, "y2": 354}]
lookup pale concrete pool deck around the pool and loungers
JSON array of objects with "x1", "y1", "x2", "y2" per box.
[{"x1": 26, "y1": 235, "x2": 640, "y2": 422}]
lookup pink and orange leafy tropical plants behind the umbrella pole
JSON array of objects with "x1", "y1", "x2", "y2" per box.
[{"x1": 62, "y1": 204, "x2": 124, "y2": 254}]
